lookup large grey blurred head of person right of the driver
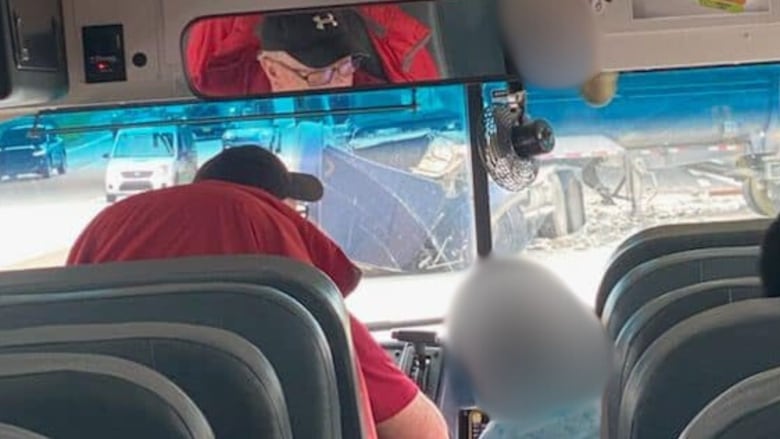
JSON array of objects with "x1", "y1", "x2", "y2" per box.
[{"x1": 447, "y1": 259, "x2": 612, "y2": 426}]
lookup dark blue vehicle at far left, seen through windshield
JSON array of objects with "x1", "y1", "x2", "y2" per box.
[{"x1": 0, "y1": 124, "x2": 68, "y2": 178}]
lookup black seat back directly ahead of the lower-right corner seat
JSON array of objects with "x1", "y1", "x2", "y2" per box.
[{"x1": 616, "y1": 299, "x2": 780, "y2": 439}]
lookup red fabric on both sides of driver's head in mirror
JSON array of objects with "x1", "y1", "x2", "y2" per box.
[{"x1": 186, "y1": 5, "x2": 439, "y2": 96}]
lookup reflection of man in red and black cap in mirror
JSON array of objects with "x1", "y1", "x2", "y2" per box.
[{"x1": 186, "y1": 5, "x2": 440, "y2": 96}]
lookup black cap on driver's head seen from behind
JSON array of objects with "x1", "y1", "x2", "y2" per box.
[{"x1": 195, "y1": 145, "x2": 324, "y2": 202}]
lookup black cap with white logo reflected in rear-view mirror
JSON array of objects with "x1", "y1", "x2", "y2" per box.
[{"x1": 258, "y1": 9, "x2": 360, "y2": 69}]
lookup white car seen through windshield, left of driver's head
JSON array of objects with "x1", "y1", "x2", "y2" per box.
[{"x1": 105, "y1": 126, "x2": 198, "y2": 203}]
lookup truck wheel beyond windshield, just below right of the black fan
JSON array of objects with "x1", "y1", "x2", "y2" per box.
[{"x1": 539, "y1": 170, "x2": 586, "y2": 239}]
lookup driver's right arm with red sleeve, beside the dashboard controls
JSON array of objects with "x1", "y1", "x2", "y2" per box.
[{"x1": 350, "y1": 316, "x2": 449, "y2": 439}]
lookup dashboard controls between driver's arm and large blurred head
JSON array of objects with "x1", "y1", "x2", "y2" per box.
[{"x1": 382, "y1": 331, "x2": 490, "y2": 439}]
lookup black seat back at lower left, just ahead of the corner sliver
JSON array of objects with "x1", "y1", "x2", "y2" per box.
[{"x1": 0, "y1": 354, "x2": 214, "y2": 439}]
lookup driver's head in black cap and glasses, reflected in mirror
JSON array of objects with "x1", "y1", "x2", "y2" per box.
[{"x1": 258, "y1": 10, "x2": 361, "y2": 92}]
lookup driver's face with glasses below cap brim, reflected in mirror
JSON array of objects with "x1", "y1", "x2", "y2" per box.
[{"x1": 258, "y1": 51, "x2": 355, "y2": 92}]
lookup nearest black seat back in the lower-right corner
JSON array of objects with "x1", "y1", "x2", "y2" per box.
[{"x1": 680, "y1": 368, "x2": 780, "y2": 439}]
